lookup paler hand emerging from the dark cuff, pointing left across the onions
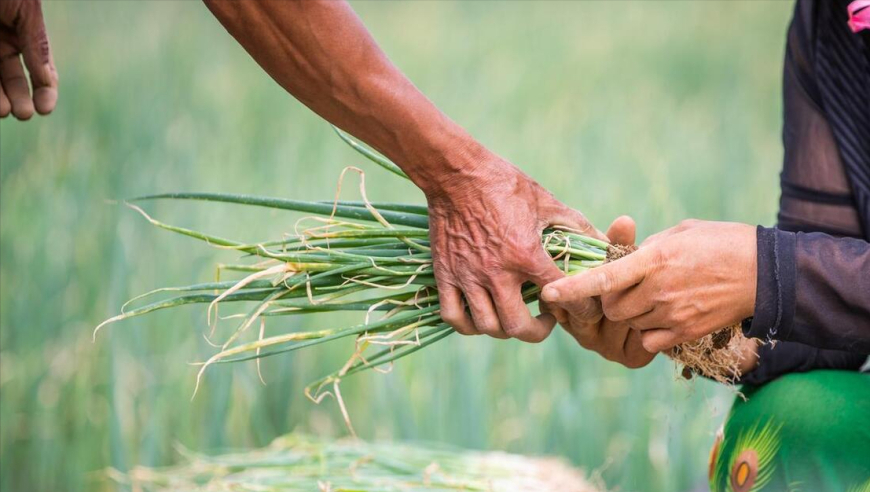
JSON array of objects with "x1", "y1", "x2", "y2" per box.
[{"x1": 542, "y1": 220, "x2": 756, "y2": 352}]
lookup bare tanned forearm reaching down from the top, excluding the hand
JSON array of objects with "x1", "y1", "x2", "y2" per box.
[{"x1": 205, "y1": 0, "x2": 487, "y2": 195}]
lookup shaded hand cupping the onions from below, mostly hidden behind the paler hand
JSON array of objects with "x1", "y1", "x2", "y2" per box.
[{"x1": 541, "y1": 216, "x2": 655, "y2": 369}]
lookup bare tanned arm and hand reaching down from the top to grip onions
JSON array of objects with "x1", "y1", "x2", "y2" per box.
[{"x1": 205, "y1": 0, "x2": 601, "y2": 341}]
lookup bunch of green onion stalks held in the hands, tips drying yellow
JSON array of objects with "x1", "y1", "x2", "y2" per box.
[{"x1": 94, "y1": 129, "x2": 608, "y2": 430}]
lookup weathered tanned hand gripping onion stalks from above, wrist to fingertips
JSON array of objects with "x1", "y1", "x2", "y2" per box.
[{"x1": 427, "y1": 155, "x2": 603, "y2": 342}]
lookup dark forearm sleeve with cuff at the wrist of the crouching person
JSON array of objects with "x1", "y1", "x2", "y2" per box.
[{"x1": 745, "y1": 227, "x2": 870, "y2": 354}]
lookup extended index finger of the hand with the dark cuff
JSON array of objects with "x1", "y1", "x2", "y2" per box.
[{"x1": 541, "y1": 248, "x2": 654, "y2": 304}]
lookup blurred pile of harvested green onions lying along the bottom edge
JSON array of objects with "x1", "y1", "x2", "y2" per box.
[{"x1": 109, "y1": 434, "x2": 599, "y2": 492}]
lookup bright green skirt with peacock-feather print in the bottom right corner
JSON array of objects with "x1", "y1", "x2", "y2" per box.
[{"x1": 710, "y1": 371, "x2": 870, "y2": 492}]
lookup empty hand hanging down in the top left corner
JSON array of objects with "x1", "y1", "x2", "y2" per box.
[{"x1": 0, "y1": 0, "x2": 57, "y2": 120}]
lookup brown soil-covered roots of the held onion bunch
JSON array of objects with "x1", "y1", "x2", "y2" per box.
[{"x1": 606, "y1": 244, "x2": 746, "y2": 385}]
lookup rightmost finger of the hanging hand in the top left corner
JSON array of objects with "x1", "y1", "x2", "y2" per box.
[{"x1": 17, "y1": 1, "x2": 57, "y2": 114}]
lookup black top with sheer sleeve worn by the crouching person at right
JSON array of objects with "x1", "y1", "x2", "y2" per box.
[{"x1": 743, "y1": 0, "x2": 870, "y2": 384}]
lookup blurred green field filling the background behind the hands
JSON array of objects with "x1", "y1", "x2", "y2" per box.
[{"x1": 0, "y1": 1, "x2": 792, "y2": 492}]
